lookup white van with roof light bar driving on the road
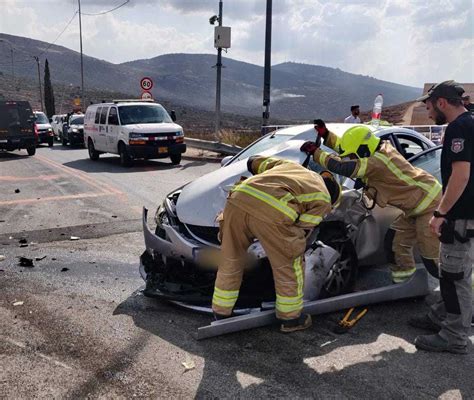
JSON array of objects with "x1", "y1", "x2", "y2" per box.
[{"x1": 84, "y1": 100, "x2": 186, "y2": 167}]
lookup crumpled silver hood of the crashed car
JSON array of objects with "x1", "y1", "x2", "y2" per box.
[{"x1": 176, "y1": 137, "x2": 306, "y2": 226}]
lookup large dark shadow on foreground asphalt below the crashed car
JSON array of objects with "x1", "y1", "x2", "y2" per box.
[{"x1": 114, "y1": 296, "x2": 474, "y2": 399}]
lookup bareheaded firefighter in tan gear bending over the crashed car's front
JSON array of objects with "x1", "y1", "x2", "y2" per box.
[{"x1": 212, "y1": 156, "x2": 341, "y2": 332}]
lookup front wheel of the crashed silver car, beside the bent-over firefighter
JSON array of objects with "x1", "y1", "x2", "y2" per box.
[{"x1": 320, "y1": 239, "x2": 358, "y2": 298}]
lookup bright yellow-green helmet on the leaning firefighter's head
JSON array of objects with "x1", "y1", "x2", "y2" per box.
[{"x1": 339, "y1": 126, "x2": 380, "y2": 158}]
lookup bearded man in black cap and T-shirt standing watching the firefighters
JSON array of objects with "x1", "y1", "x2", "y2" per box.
[{"x1": 410, "y1": 81, "x2": 474, "y2": 354}]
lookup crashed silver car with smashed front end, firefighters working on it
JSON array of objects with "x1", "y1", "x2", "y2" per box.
[{"x1": 140, "y1": 124, "x2": 440, "y2": 311}]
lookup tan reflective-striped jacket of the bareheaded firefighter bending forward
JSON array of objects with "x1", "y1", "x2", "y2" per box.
[{"x1": 227, "y1": 157, "x2": 332, "y2": 229}]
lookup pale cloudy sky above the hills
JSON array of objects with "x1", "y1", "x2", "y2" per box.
[{"x1": 0, "y1": 0, "x2": 474, "y2": 87}]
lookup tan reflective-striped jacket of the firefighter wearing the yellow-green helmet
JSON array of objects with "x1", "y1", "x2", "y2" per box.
[{"x1": 313, "y1": 132, "x2": 441, "y2": 216}]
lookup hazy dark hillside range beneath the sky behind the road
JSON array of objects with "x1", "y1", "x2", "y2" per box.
[{"x1": 0, "y1": 34, "x2": 421, "y2": 122}]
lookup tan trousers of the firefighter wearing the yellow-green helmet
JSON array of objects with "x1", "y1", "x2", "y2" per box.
[{"x1": 390, "y1": 210, "x2": 439, "y2": 283}]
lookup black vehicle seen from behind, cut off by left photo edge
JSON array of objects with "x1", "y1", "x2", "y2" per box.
[{"x1": 0, "y1": 100, "x2": 38, "y2": 156}]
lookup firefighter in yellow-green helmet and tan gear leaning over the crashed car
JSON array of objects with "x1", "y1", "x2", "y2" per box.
[{"x1": 301, "y1": 120, "x2": 441, "y2": 283}]
